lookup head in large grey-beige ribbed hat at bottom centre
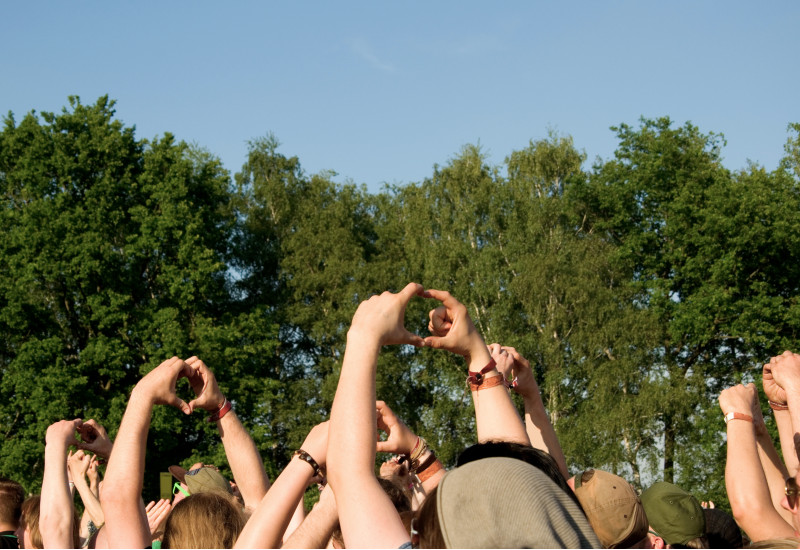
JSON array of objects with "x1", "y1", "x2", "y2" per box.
[{"x1": 414, "y1": 457, "x2": 600, "y2": 548}]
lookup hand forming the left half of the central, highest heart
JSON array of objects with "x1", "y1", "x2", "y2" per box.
[{"x1": 349, "y1": 283, "x2": 425, "y2": 347}]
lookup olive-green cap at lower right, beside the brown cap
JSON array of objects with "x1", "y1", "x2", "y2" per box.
[{"x1": 642, "y1": 481, "x2": 706, "y2": 544}]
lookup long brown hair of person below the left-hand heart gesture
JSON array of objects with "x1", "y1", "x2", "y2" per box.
[{"x1": 161, "y1": 491, "x2": 245, "y2": 548}]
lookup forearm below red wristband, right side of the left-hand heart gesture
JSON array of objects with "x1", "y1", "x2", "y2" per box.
[{"x1": 217, "y1": 410, "x2": 269, "y2": 508}]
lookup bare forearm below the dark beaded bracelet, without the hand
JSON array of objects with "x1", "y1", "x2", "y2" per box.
[{"x1": 234, "y1": 457, "x2": 314, "y2": 548}]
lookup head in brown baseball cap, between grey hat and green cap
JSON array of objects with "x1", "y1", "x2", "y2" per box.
[{"x1": 572, "y1": 469, "x2": 649, "y2": 548}]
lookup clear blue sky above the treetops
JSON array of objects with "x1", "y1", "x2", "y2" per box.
[{"x1": 0, "y1": 0, "x2": 800, "y2": 192}]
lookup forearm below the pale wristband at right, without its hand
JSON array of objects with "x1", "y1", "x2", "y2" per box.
[{"x1": 725, "y1": 420, "x2": 794, "y2": 542}]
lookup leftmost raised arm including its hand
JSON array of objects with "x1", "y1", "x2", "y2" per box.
[{"x1": 39, "y1": 419, "x2": 81, "y2": 548}]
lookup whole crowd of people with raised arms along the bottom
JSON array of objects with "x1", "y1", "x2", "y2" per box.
[{"x1": 0, "y1": 283, "x2": 800, "y2": 548}]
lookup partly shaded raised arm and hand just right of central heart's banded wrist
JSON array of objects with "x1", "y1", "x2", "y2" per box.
[{"x1": 489, "y1": 344, "x2": 569, "y2": 479}]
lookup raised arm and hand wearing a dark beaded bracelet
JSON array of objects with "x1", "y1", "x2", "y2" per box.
[{"x1": 234, "y1": 422, "x2": 328, "y2": 548}]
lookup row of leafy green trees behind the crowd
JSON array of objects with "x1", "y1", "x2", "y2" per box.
[{"x1": 0, "y1": 97, "x2": 800, "y2": 502}]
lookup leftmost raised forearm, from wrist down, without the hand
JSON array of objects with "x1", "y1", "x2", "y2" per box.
[{"x1": 39, "y1": 441, "x2": 73, "y2": 548}]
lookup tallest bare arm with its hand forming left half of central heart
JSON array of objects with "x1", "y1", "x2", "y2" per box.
[{"x1": 328, "y1": 283, "x2": 424, "y2": 548}]
